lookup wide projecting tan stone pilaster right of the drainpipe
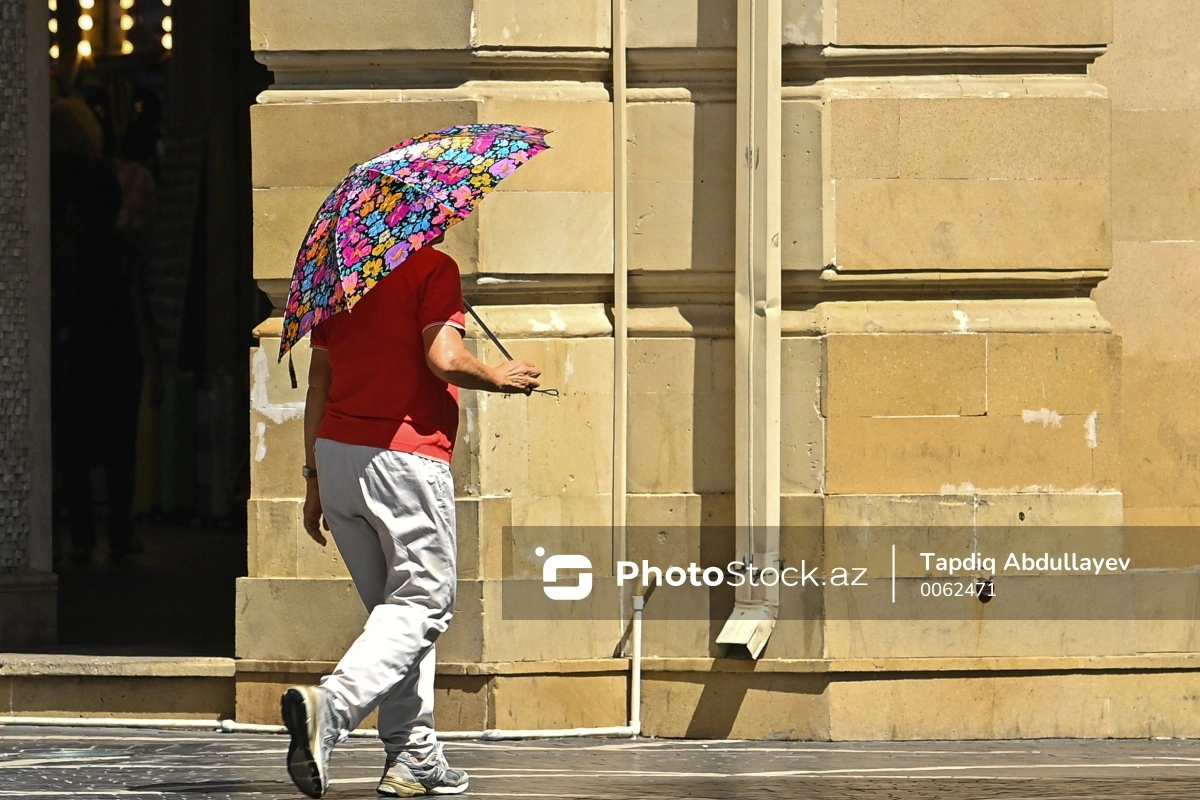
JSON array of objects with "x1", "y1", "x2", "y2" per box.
[{"x1": 815, "y1": 0, "x2": 1123, "y2": 739}]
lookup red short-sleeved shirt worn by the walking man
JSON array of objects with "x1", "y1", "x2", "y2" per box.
[{"x1": 312, "y1": 247, "x2": 466, "y2": 461}]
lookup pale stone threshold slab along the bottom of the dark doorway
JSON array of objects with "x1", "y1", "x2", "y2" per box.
[{"x1": 0, "y1": 652, "x2": 235, "y2": 678}]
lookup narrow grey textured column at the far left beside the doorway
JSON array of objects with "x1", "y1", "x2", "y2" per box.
[{"x1": 0, "y1": 0, "x2": 58, "y2": 649}]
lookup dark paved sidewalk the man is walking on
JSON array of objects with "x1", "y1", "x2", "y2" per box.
[{"x1": 0, "y1": 727, "x2": 1200, "y2": 800}]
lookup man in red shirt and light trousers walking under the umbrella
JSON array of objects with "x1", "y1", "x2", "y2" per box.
[{"x1": 282, "y1": 239, "x2": 541, "y2": 798}]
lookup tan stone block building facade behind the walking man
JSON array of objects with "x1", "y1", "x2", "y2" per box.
[{"x1": 0, "y1": 0, "x2": 1200, "y2": 739}]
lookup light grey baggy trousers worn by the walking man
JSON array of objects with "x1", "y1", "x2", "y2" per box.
[{"x1": 316, "y1": 439, "x2": 457, "y2": 758}]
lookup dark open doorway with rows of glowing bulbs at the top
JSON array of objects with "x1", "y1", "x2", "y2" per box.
[{"x1": 39, "y1": 0, "x2": 270, "y2": 656}]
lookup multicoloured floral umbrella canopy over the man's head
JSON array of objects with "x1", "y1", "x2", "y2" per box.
[{"x1": 280, "y1": 124, "x2": 550, "y2": 360}]
